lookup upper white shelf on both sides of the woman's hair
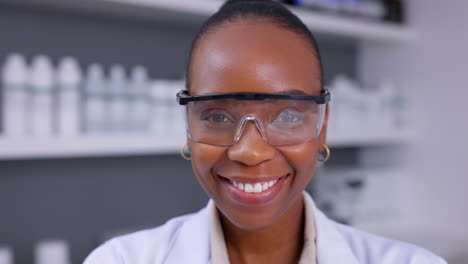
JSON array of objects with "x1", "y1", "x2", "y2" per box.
[{"x1": 2, "y1": 0, "x2": 417, "y2": 43}]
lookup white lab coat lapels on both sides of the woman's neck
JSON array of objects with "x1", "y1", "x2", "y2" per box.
[{"x1": 164, "y1": 192, "x2": 359, "y2": 264}]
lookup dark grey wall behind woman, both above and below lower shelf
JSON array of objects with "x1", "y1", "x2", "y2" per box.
[{"x1": 0, "y1": 5, "x2": 357, "y2": 263}]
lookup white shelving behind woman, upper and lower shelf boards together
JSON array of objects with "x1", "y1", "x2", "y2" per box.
[{"x1": 0, "y1": 0, "x2": 417, "y2": 160}]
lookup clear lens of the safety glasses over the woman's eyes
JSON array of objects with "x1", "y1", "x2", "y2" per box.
[{"x1": 187, "y1": 99, "x2": 325, "y2": 146}]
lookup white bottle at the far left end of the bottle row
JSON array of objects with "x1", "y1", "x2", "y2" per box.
[{"x1": 2, "y1": 54, "x2": 29, "y2": 138}]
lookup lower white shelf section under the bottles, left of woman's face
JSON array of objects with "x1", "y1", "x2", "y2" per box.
[{"x1": 0, "y1": 134, "x2": 186, "y2": 160}]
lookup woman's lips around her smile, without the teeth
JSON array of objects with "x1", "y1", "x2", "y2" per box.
[{"x1": 218, "y1": 174, "x2": 290, "y2": 204}]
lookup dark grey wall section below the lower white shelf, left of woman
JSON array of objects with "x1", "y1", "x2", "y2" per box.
[{"x1": 0, "y1": 156, "x2": 207, "y2": 263}]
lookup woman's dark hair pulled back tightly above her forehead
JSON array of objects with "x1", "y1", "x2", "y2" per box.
[{"x1": 186, "y1": 0, "x2": 323, "y2": 89}]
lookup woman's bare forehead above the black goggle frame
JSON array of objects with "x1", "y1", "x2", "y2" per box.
[{"x1": 190, "y1": 21, "x2": 321, "y2": 95}]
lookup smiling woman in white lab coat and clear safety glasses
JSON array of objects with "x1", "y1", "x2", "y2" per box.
[{"x1": 85, "y1": 0, "x2": 445, "y2": 264}]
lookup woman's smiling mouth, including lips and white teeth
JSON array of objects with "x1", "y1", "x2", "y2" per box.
[{"x1": 218, "y1": 174, "x2": 290, "y2": 204}]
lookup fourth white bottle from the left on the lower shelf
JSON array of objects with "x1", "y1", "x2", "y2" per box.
[{"x1": 83, "y1": 63, "x2": 108, "y2": 133}]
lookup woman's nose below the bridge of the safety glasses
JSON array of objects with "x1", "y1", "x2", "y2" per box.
[{"x1": 228, "y1": 122, "x2": 276, "y2": 166}]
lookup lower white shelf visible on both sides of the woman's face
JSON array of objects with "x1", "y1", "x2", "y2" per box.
[{"x1": 0, "y1": 127, "x2": 414, "y2": 160}]
